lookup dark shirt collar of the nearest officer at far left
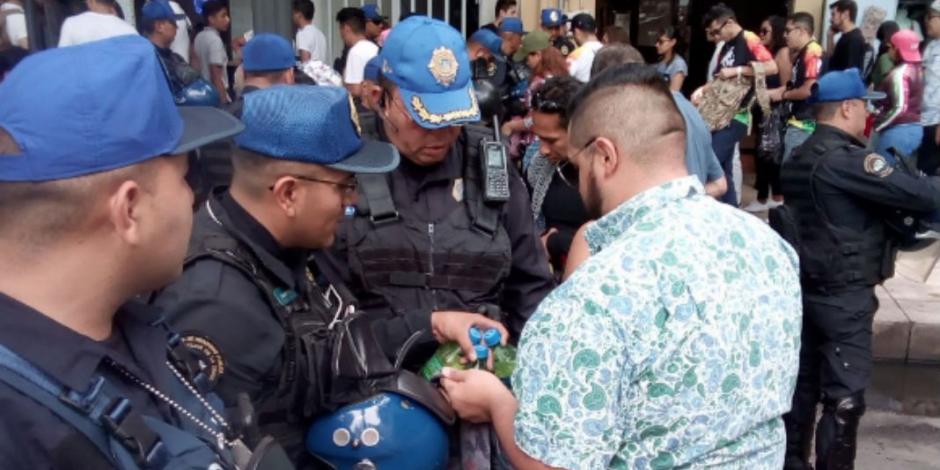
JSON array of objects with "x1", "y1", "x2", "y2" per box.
[{"x1": 0, "y1": 293, "x2": 167, "y2": 391}]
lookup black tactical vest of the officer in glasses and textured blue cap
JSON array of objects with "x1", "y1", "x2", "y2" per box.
[{"x1": 185, "y1": 199, "x2": 454, "y2": 461}]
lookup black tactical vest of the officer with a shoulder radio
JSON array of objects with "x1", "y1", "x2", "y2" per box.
[{"x1": 346, "y1": 126, "x2": 512, "y2": 320}]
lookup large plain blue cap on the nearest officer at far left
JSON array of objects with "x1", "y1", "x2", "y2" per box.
[{"x1": 0, "y1": 35, "x2": 243, "y2": 182}]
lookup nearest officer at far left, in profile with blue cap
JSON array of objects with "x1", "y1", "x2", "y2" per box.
[{"x1": 0, "y1": 36, "x2": 241, "y2": 469}]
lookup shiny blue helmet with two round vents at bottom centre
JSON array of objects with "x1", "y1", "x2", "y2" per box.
[{"x1": 306, "y1": 392, "x2": 449, "y2": 470}]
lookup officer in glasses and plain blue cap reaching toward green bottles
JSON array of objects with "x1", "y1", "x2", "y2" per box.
[{"x1": 154, "y1": 86, "x2": 499, "y2": 467}]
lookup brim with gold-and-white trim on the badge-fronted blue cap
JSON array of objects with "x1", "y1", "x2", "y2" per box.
[{"x1": 399, "y1": 82, "x2": 480, "y2": 129}]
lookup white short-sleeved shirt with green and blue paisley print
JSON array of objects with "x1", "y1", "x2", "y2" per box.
[{"x1": 512, "y1": 177, "x2": 802, "y2": 469}]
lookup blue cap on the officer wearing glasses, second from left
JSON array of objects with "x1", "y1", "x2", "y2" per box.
[{"x1": 235, "y1": 85, "x2": 399, "y2": 173}]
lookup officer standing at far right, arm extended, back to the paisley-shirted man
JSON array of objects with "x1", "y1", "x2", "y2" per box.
[{"x1": 775, "y1": 69, "x2": 940, "y2": 470}]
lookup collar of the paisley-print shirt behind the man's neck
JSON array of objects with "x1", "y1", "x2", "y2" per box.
[{"x1": 585, "y1": 176, "x2": 705, "y2": 255}]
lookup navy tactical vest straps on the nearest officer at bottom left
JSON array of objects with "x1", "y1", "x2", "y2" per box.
[{"x1": 0, "y1": 335, "x2": 236, "y2": 470}]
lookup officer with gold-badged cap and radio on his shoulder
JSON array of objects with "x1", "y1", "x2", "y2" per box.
[{"x1": 320, "y1": 16, "x2": 553, "y2": 366}]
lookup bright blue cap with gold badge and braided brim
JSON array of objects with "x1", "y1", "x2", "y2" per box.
[{"x1": 379, "y1": 16, "x2": 480, "y2": 129}]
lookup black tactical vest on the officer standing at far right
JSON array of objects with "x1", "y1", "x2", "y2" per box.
[{"x1": 775, "y1": 141, "x2": 897, "y2": 289}]
